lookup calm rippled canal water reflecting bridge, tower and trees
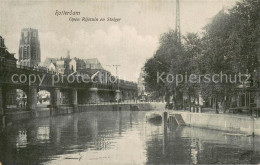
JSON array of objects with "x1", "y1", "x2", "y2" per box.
[{"x1": 0, "y1": 111, "x2": 260, "y2": 165}]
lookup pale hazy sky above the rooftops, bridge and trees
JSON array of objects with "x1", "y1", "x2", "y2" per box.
[{"x1": 0, "y1": 0, "x2": 240, "y2": 82}]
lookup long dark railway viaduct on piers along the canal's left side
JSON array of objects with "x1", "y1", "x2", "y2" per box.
[{"x1": 0, "y1": 46, "x2": 137, "y2": 114}]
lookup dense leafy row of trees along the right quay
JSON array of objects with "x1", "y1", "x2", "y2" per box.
[{"x1": 144, "y1": 0, "x2": 260, "y2": 112}]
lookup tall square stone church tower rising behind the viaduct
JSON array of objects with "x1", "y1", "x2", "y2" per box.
[{"x1": 18, "y1": 28, "x2": 41, "y2": 67}]
